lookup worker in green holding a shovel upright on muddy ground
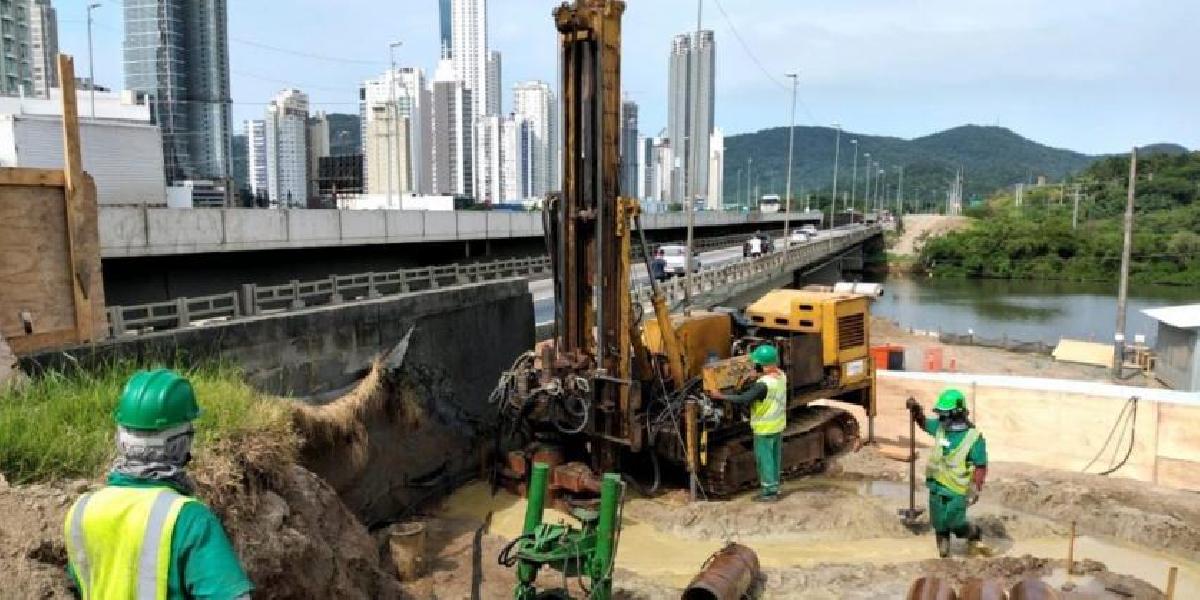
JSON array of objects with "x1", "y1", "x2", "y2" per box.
[{"x1": 907, "y1": 388, "x2": 989, "y2": 558}]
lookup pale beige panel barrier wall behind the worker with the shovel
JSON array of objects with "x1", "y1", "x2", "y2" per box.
[{"x1": 875, "y1": 371, "x2": 1200, "y2": 491}]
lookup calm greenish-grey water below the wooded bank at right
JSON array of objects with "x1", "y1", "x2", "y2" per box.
[{"x1": 871, "y1": 277, "x2": 1200, "y2": 344}]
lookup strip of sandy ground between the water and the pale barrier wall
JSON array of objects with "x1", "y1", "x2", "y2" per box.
[{"x1": 871, "y1": 318, "x2": 1162, "y2": 388}]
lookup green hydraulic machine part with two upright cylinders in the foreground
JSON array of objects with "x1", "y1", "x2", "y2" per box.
[{"x1": 499, "y1": 462, "x2": 624, "y2": 600}]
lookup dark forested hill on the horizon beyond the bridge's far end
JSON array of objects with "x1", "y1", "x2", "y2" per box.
[{"x1": 725, "y1": 125, "x2": 1096, "y2": 204}]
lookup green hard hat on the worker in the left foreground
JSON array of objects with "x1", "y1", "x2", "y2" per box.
[{"x1": 113, "y1": 368, "x2": 200, "y2": 431}]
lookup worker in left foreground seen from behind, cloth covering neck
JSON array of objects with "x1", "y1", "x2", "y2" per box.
[{"x1": 64, "y1": 370, "x2": 253, "y2": 600}]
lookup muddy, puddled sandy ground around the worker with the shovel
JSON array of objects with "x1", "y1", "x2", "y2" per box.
[{"x1": 386, "y1": 448, "x2": 1200, "y2": 599}]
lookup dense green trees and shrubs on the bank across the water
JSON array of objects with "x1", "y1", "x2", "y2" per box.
[{"x1": 920, "y1": 152, "x2": 1200, "y2": 286}]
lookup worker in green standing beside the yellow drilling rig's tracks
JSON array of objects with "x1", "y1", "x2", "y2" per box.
[{"x1": 713, "y1": 344, "x2": 787, "y2": 502}]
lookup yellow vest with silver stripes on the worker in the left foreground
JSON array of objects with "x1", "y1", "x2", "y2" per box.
[{"x1": 65, "y1": 486, "x2": 194, "y2": 600}]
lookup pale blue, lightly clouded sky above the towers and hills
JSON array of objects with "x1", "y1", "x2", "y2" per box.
[{"x1": 54, "y1": 0, "x2": 1200, "y2": 154}]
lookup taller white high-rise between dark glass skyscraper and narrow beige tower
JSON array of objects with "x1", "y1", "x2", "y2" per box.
[{"x1": 265, "y1": 90, "x2": 308, "y2": 208}]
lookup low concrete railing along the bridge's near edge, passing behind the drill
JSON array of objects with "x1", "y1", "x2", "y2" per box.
[{"x1": 108, "y1": 228, "x2": 877, "y2": 337}]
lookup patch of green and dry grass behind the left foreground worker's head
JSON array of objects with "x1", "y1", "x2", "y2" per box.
[{"x1": 0, "y1": 362, "x2": 294, "y2": 484}]
